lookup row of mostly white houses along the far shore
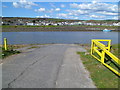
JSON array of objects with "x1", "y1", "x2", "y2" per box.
[{"x1": 2, "y1": 19, "x2": 120, "y2": 26}]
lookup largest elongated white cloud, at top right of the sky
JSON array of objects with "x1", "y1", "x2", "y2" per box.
[{"x1": 70, "y1": 1, "x2": 118, "y2": 12}]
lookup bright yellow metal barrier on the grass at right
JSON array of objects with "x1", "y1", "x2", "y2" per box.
[{"x1": 91, "y1": 39, "x2": 120, "y2": 76}]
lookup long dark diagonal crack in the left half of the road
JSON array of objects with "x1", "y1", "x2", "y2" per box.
[{"x1": 8, "y1": 56, "x2": 47, "y2": 88}]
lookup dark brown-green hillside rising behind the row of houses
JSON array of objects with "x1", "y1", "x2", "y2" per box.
[{"x1": 2, "y1": 17, "x2": 119, "y2": 23}]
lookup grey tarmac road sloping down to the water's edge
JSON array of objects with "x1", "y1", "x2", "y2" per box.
[{"x1": 2, "y1": 44, "x2": 96, "y2": 88}]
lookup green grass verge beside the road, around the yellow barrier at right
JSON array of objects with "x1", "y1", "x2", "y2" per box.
[{"x1": 77, "y1": 44, "x2": 119, "y2": 88}]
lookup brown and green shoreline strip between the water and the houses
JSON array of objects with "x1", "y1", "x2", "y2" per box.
[{"x1": 2, "y1": 26, "x2": 120, "y2": 32}]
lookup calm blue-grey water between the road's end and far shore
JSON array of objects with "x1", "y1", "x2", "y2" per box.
[{"x1": 0, "y1": 31, "x2": 118, "y2": 44}]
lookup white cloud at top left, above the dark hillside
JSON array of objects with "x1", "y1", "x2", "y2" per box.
[{"x1": 13, "y1": 0, "x2": 38, "y2": 9}]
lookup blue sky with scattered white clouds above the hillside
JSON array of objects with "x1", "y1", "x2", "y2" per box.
[{"x1": 2, "y1": 0, "x2": 118, "y2": 20}]
